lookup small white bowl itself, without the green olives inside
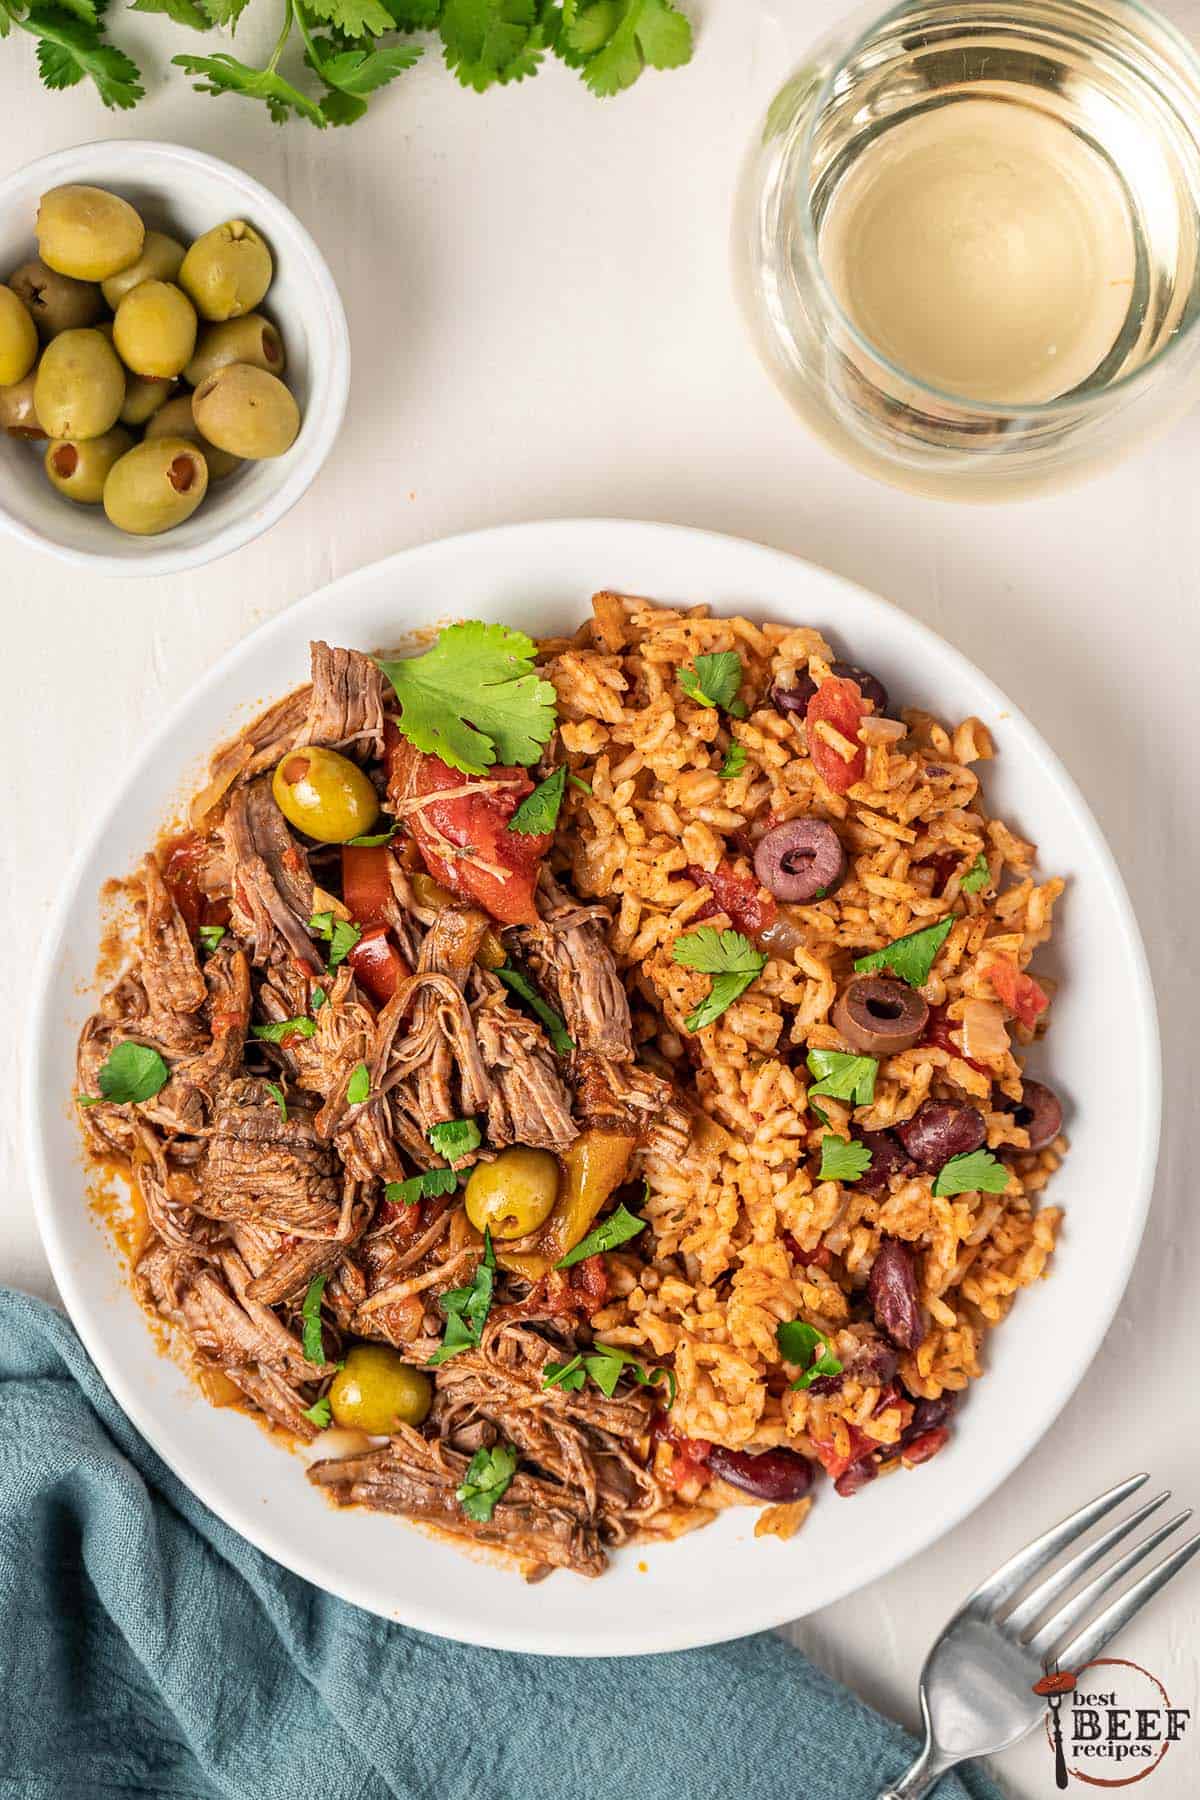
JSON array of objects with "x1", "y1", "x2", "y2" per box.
[{"x1": 0, "y1": 139, "x2": 351, "y2": 576}]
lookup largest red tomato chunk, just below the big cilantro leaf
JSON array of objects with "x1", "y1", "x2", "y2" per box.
[{"x1": 387, "y1": 727, "x2": 554, "y2": 925}]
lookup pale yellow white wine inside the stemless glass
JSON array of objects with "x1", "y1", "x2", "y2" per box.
[{"x1": 819, "y1": 99, "x2": 1137, "y2": 405}]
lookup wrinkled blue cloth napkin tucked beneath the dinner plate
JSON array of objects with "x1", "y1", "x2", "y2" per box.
[{"x1": 0, "y1": 1287, "x2": 1000, "y2": 1800}]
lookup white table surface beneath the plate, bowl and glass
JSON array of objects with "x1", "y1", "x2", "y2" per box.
[{"x1": 0, "y1": 0, "x2": 1200, "y2": 1800}]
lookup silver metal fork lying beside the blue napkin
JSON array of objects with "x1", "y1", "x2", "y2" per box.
[{"x1": 878, "y1": 1474, "x2": 1200, "y2": 1800}]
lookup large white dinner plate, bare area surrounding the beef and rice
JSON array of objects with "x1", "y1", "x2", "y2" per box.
[{"x1": 25, "y1": 520, "x2": 1159, "y2": 1656}]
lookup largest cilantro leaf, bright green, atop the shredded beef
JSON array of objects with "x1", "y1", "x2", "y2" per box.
[{"x1": 380, "y1": 619, "x2": 556, "y2": 776}]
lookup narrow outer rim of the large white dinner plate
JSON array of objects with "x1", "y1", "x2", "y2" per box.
[{"x1": 22, "y1": 517, "x2": 1162, "y2": 1658}]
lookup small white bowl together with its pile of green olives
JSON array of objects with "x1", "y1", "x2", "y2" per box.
[{"x1": 0, "y1": 140, "x2": 351, "y2": 576}]
